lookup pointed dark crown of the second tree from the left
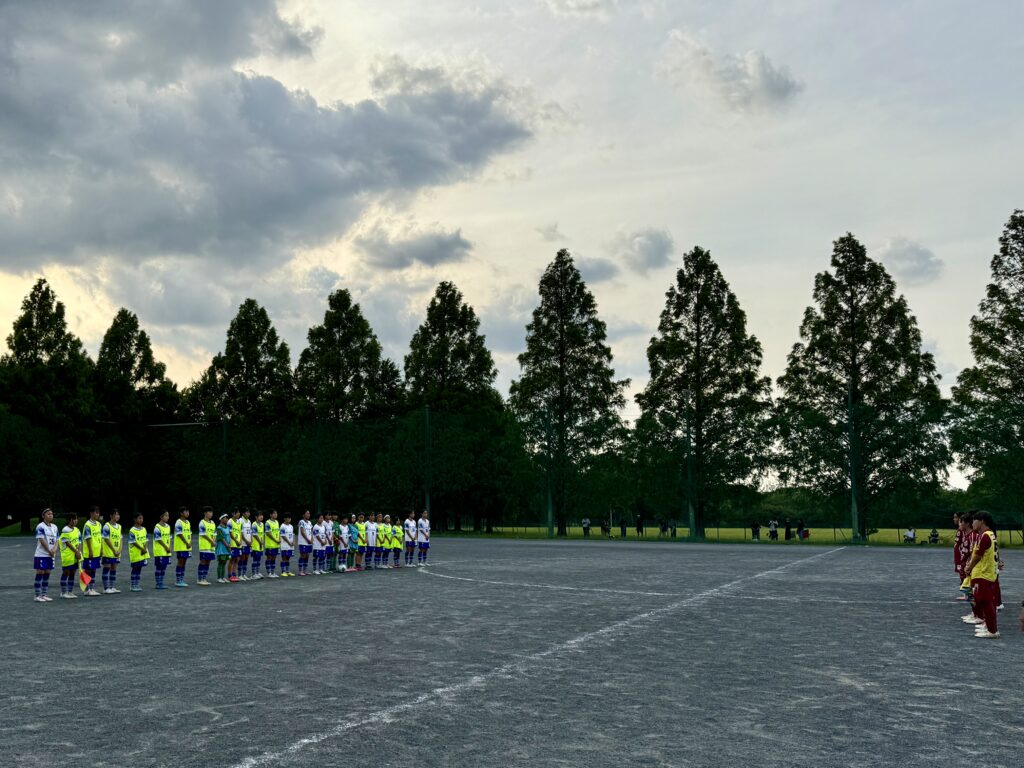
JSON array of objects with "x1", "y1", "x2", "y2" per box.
[{"x1": 95, "y1": 307, "x2": 178, "y2": 423}]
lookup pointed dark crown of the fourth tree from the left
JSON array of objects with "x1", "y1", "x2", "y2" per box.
[{"x1": 295, "y1": 289, "x2": 401, "y2": 421}]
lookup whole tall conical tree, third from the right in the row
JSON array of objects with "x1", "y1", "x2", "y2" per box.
[{"x1": 637, "y1": 248, "x2": 771, "y2": 538}]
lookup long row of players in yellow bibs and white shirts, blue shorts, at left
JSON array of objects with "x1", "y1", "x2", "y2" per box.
[{"x1": 33, "y1": 507, "x2": 430, "y2": 602}]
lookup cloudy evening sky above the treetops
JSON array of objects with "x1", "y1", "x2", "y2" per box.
[{"x1": 0, "y1": 0, "x2": 1024, "y2": 438}]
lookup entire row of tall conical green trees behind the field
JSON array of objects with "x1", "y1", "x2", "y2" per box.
[{"x1": 0, "y1": 211, "x2": 1024, "y2": 536}]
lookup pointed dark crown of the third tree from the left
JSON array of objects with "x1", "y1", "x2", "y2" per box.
[{"x1": 184, "y1": 299, "x2": 293, "y2": 424}]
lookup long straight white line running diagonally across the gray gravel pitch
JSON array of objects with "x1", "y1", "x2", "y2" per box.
[{"x1": 231, "y1": 547, "x2": 846, "y2": 768}]
